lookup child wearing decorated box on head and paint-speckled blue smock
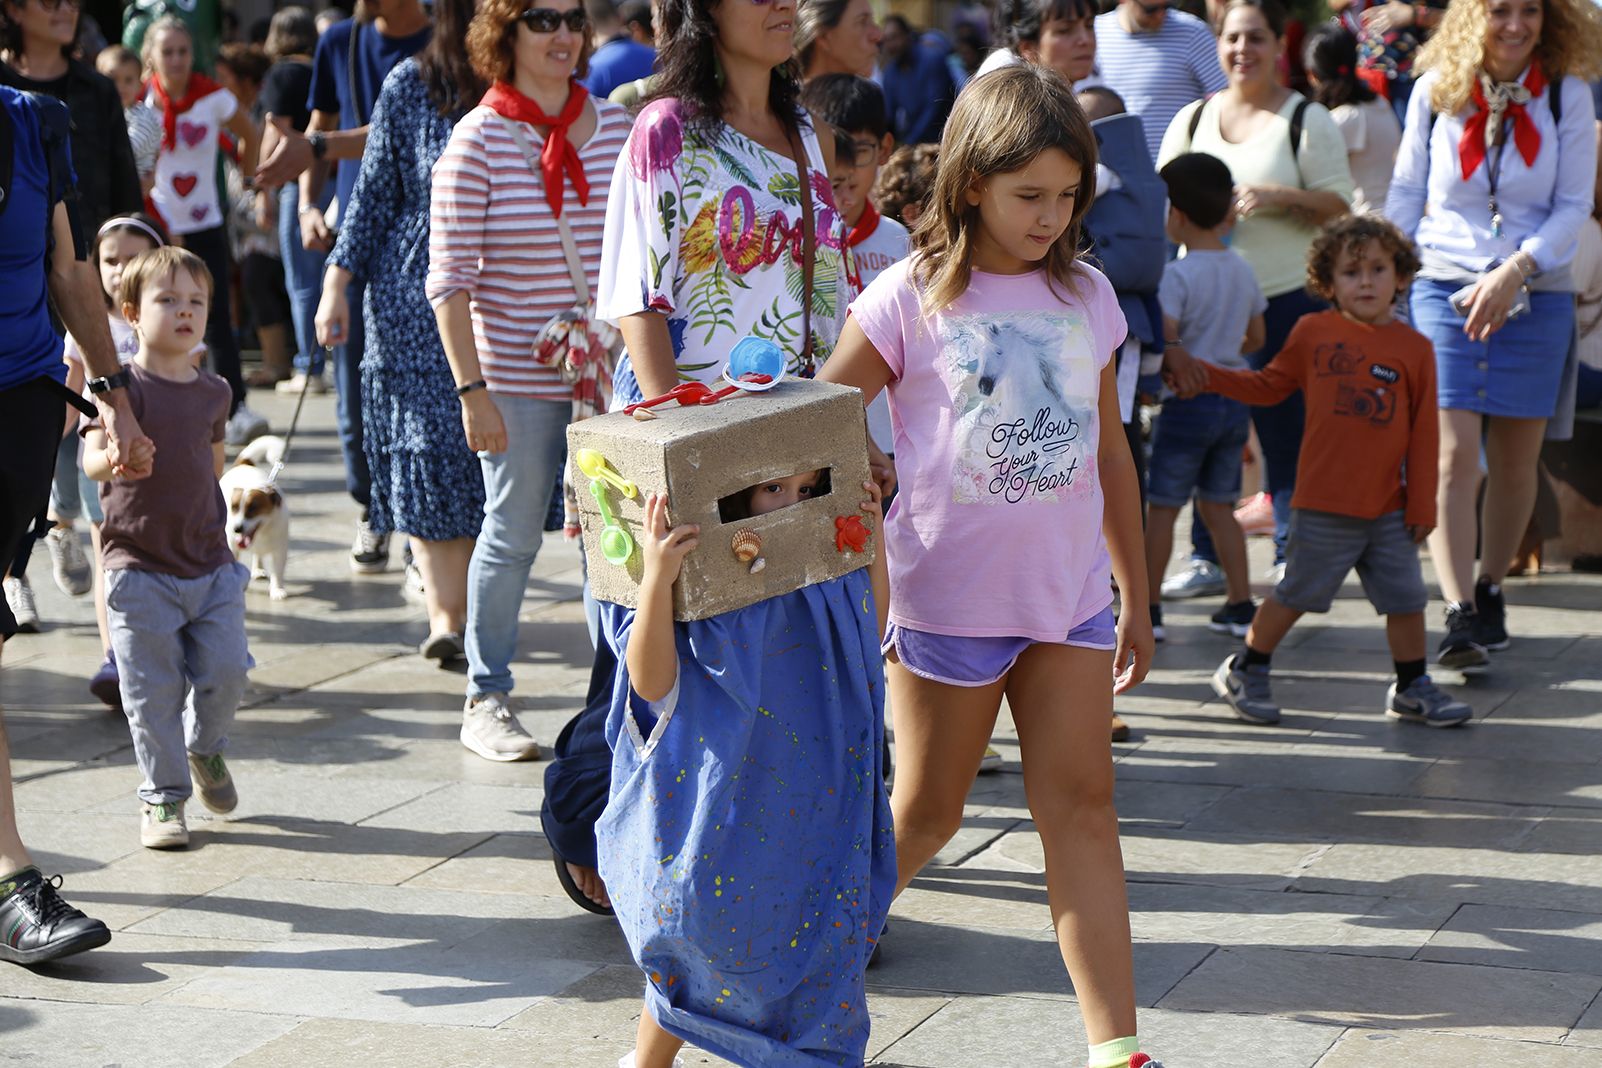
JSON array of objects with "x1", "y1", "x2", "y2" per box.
[{"x1": 569, "y1": 369, "x2": 896, "y2": 1065}]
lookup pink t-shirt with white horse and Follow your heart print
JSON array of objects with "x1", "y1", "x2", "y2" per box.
[{"x1": 851, "y1": 259, "x2": 1126, "y2": 642}]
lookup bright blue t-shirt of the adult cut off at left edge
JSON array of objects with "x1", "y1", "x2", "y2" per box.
[{"x1": 0, "y1": 86, "x2": 67, "y2": 389}]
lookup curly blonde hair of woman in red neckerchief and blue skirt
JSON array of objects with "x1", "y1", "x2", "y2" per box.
[{"x1": 1415, "y1": 0, "x2": 1602, "y2": 115}]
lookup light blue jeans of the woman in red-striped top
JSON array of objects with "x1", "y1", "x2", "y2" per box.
[{"x1": 466, "y1": 394, "x2": 572, "y2": 698}]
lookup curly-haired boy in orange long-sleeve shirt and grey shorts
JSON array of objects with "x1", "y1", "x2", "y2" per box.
[{"x1": 1169, "y1": 215, "x2": 1472, "y2": 727}]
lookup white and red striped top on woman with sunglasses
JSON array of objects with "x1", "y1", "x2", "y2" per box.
[{"x1": 426, "y1": 101, "x2": 634, "y2": 400}]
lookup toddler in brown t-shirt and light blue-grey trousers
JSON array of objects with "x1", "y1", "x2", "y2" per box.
[{"x1": 83, "y1": 247, "x2": 252, "y2": 849}]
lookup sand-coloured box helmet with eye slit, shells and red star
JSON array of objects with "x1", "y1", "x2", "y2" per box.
[{"x1": 567, "y1": 378, "x2": 879, "y2": 620}]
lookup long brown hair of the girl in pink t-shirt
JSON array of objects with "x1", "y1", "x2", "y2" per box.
[{"x1": 912, "y1": 64, "x2": 1096, "y2": 314}]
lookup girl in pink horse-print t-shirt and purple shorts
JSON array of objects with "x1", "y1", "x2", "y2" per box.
[{"x1": 819, "y1": 66, "x2": 1155, "y2": 1068}]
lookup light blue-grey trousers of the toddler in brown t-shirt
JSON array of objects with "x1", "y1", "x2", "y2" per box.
[{"x1": 106, "y1": 564, "x2": 255, "y2": 805}]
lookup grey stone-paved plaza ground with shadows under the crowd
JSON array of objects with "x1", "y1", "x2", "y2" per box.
[{"x1": 0, "y1": 394, "x2": 1602, "y2": 1068}]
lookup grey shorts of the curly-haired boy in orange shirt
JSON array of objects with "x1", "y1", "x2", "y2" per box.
[{"x1": 1274, "y1": 508, "x2": 1429, "y2": 615}]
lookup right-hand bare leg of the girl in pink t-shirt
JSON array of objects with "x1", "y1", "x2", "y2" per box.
[{"x1": 1006, "y1": 645, "x2": 1136, "y2": 1046}]
